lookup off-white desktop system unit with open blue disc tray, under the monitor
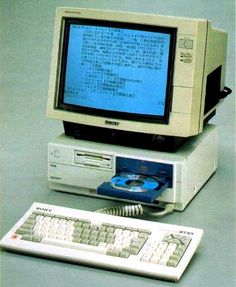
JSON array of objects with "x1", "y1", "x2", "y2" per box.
[{"x1": 48, "y1": 125, "x2": 217, "y2": 210}]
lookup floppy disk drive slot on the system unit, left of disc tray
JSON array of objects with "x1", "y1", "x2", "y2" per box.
[{"x1": 74, "y1": 150, "x2": 112, "y2": 169}]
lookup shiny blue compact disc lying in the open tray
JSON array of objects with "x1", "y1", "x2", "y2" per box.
[{"x1": 111, "y1": 173, "x2": 159, "y2": 192}]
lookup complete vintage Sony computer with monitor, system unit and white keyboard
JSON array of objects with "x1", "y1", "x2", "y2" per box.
[{"x1": 0, "y1": 8, "x2": 231, "y2": 281}]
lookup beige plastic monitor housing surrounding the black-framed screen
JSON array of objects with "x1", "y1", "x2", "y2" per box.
[{"x1": 47, "y1": 8, "x2": 227, "y2": 137}]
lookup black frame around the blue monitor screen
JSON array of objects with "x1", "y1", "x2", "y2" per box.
[{"x1": 54, "y1": 17, "x2": 177, "y2": 124}]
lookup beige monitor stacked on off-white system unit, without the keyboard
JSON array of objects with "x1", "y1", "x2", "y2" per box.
[{"x1": 47, "y1": 8, "x2": 230, "y2": 214}]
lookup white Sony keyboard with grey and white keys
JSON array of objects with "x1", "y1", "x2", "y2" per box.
[{"x1": 0, "y1": 202, "x2": 203, "y2": 281}]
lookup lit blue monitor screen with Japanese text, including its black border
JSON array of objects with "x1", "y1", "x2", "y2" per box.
[{"x1": 57, "y1": 19, "x2": 176, "y2": 122}]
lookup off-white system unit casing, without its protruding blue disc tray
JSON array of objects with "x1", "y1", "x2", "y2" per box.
[{"x1": 48, "y1": 125, "x2": 217, "y2": 210}]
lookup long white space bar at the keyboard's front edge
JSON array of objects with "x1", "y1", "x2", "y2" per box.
[{"x1": 41, "y1": 237, "x2": 107, "y2": 254}]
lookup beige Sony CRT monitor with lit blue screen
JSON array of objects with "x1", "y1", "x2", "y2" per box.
[{"x1": 48, "y1": 8, "x2": 230, "y2": 138}]
